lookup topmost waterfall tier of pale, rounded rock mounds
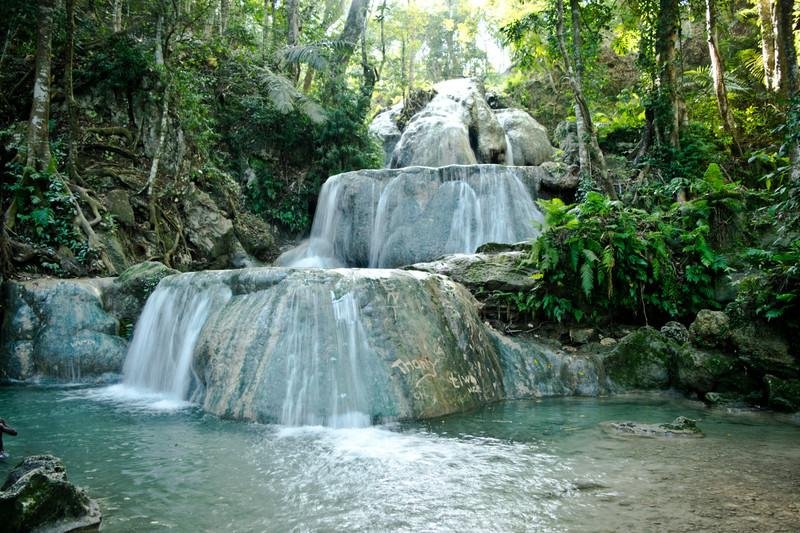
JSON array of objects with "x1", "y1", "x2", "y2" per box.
[{"x1": 370, "y1": 78, "x2": 553, "y2": 168}]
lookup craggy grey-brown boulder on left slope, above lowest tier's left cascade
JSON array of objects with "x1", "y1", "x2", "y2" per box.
[{"x1": 183, "y1": 186, "x2": 236, "y2": 268}]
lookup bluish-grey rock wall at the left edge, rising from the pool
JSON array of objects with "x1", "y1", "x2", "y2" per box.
[{"x1": 0, "y1": 278, "x2": 127, "y2": 381}]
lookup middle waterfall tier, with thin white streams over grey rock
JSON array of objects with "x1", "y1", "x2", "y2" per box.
[{"x1": 277, "y1": 165, "x2": 543, "y2": 268}]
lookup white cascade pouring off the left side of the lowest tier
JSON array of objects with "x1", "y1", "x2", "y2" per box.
[{"x1": 123, "y1": 274, "x2": 231, "y2": 400}]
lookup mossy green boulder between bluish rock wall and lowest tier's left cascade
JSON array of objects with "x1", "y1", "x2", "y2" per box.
[{"x1": 103, "y1": 261, "x2": 178, "y2": 333}]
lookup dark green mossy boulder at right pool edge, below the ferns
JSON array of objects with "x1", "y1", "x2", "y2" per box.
[{"x1": 603, "y1": 326, "x2": 676, "y2": 389}]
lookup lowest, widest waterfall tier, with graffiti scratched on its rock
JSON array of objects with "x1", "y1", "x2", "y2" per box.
[{"x1": 125, "y1": 268, "x2": 503, "y2": 426}]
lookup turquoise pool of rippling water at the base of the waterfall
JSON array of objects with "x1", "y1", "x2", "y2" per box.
[{"x1": 0, "y1": 386, "x2": 800, "y2": 532}]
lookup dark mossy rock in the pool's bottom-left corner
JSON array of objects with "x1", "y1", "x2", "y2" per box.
[{"x1": 0, "y1": 455, "x2": 102, "y2": 532}]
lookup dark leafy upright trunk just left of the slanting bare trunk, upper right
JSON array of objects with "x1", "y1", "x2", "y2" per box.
[{"x1": 656, "y1": 0, "x2": 683, "y2": 149}]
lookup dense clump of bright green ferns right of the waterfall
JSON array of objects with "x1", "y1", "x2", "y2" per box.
[{"x1": 528, "y1": 192, "x2": 726, "y2": 321}]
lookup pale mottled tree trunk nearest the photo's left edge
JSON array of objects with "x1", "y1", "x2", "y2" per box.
[{"x1": 26, "y1": 0, "x2": 55, "y2": 170}]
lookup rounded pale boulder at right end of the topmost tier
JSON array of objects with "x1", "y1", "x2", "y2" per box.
[{"x1": 495, "y1": 109, "x2": 553, "y2": 165}]
